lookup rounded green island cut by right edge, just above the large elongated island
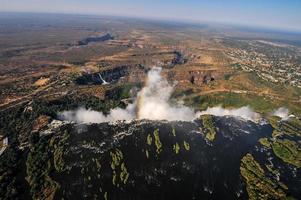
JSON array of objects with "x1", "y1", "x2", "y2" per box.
[{"x1": 272, "y1": 139, "x2": 301, "y2": 168}]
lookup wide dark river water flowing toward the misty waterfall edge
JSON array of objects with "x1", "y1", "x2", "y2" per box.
[{"x1": 47, "y1": 117, "x2": 286, "y2": 199}]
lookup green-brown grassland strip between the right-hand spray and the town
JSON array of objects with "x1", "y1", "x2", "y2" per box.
[{"x1": 185, "y1": 72, "x2": 301, "y2": 116}]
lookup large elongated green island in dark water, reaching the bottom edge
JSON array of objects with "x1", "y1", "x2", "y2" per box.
[{"x1": 240, "y1": 154, "x2": 286, "y2": 200}]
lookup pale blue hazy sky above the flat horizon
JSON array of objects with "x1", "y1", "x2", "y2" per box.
[{"x1": 0, "y1": 0, "x2": 301, "y2": 31}]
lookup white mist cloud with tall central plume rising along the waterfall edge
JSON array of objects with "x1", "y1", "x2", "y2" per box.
[{"x1": 60, "y1": 67, "x2": 259, "y2": 123}]
